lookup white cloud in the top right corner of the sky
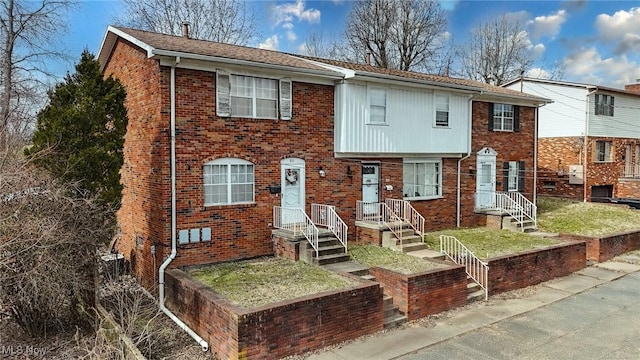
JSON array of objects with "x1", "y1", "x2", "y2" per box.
[{"x1": 595, "y1": 7, "x2": 640, "y2": 55}]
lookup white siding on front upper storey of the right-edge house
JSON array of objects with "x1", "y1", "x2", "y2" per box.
[{"x1": 588, "y1": 93, "x2": 640, "y2": 139}]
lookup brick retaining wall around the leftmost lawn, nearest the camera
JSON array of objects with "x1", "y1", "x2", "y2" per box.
[{"x1": 166, "y1": 269, "x2": 384, "y2": 359}]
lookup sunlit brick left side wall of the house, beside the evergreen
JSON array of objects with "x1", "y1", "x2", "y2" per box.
[{"x1": 104, "y1": 39, "x2": 170, "y2": 289}]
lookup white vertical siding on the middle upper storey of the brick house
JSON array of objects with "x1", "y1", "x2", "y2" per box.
[{"x1": 335, "y1": 83, "x2": 470, "y2": 155}]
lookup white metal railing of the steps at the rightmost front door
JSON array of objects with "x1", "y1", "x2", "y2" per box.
[{"x1": 476, "y1": 191, "x2": 538, "y2": 227}]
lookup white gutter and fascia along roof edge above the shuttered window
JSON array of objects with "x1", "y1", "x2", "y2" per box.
[{"x1": 151, "y1": 49, "x2": 342, "y2": 80}]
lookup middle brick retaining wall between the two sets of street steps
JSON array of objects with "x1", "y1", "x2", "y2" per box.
[{"x1": 369, "y1": 266, "x2": 467, "y2": 320}]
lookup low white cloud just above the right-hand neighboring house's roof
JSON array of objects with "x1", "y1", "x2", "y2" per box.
[{"x1": 564, "y1": 47, "x2": 640, "y2": 88}]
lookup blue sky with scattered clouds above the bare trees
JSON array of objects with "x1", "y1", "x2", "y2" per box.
[{"x1": 61, "y1": 0, "x2": 640, "y2": 88}]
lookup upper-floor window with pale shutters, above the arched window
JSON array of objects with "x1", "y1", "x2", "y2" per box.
[{"x1": 216, "y1": 71, "x2": 292, "y2": 120}]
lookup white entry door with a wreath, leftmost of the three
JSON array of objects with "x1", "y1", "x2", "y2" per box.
[{"x1": 280, "y1": 158, "x2": 305, "y2": 224}]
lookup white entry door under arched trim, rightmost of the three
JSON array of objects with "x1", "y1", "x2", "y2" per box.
[{"x1": 476, "y1": 148, "x2": 497, "y2": 209}]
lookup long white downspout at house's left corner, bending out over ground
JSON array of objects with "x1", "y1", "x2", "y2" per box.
[{"x1": 158, "y1": 57, "x2": 209, "y2": 351}]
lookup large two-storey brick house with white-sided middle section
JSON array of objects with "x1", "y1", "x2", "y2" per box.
[{"x1": 99, "y1": 27, "x2": 548, "y2": 289}]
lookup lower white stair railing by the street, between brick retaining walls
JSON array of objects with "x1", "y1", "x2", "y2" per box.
[{"x1": 440, "y1": 235, "x2": 489, "y2": 300}]
